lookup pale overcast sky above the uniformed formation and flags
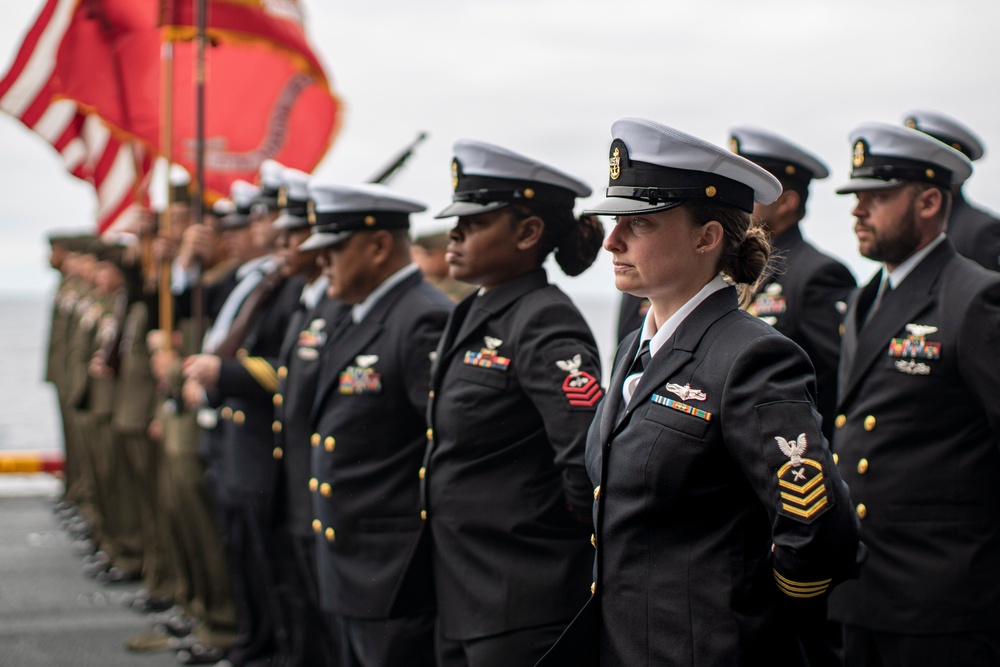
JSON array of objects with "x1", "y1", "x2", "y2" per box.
[{"x1": 0, "y1": 0, "x2": 1000, "y2": 308}]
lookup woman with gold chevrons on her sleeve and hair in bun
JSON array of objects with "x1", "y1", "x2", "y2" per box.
[{"x1": 546, "y1": 118, "x2": 863, "y2": 666}]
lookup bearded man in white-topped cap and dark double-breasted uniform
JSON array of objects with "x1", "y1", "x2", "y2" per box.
[{"x1": 830, "y1": 123, "x2": 1000, "y2": 666}]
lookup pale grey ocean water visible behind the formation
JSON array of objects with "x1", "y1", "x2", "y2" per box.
[{"x1": 0, "y1": 294, "x2": 618, "y2": 460}]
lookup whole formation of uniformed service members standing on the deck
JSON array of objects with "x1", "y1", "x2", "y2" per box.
[{"x1": 41, "y1": 105, "x2": 1000, "y2": 667}]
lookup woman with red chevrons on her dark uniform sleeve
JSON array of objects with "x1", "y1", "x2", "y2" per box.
[{"x1": 402, "y1": 141, "x2": 604, "y2": 667}]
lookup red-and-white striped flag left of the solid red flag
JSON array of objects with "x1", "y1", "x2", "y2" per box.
[{"x1": 0, "y1": 0, "x2": 151, "y2": 233}]
